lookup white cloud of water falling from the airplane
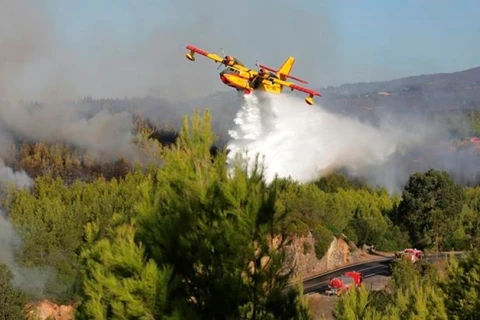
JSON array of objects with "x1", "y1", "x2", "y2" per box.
[{"x1": 228, "y1": 94, "x2": 446, "y2": 191}]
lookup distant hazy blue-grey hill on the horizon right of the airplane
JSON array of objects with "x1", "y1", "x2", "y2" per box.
[{"x1": 319, "y1": 67, "x2": 480, "y2": 115}]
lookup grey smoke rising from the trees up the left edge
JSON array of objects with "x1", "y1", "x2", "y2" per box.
[{"x1": 0, "y1": 0, "x2": 138, "y2": 160}]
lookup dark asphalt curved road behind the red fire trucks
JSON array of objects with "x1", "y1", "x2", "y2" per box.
[{"x1": 296, "y1": 252, "x2": 463, "y2": 294}]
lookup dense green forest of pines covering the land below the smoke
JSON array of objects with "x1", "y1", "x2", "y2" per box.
[{"x1": 0, "y1": 110, "x2": 480, "y2": 319}]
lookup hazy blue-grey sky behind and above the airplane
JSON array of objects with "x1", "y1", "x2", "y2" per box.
[{"x1": 8, "y1": 0, "x2": 480, "y2": 96}]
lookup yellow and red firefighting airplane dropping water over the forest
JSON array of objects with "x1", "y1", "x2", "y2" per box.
[{"x1": 186, "y1": 45, "x2": 322, "y2": 105}]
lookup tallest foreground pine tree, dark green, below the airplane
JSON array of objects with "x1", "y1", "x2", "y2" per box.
[{"x1": 133, "y1": 111, "x2": 308, "y2": 319}]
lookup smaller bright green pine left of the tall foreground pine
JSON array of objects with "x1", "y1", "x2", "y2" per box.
[{"x1": 76, "y1": 217, "x2": 181, "y2": 320}]
